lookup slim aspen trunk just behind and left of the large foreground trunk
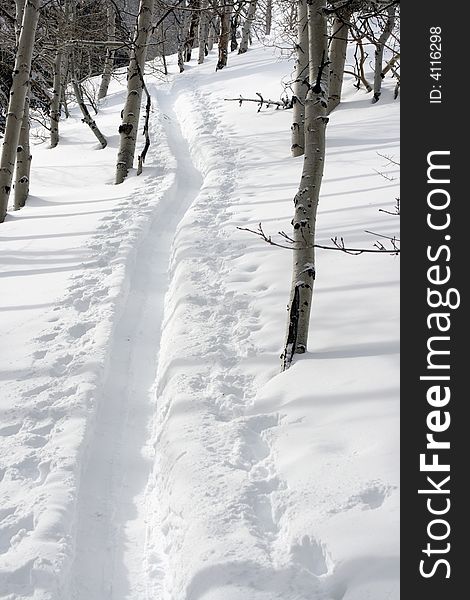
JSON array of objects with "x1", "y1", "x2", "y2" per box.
[{"x1": 291, "y1": 0, "x2": 308, "y2": 156}]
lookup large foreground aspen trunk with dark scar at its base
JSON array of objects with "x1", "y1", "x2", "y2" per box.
[{"x1": 282, "y1": 0, "x2": 329, "y2": 370}]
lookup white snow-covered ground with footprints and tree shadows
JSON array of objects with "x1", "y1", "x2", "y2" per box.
[{"x1": 0, "y1": 47, "x2": 399, "y2": 600}]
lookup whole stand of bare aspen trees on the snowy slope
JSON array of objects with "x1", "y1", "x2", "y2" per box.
[{"x1": 0, "y1": 0, "x2": 400, "y2": 369}]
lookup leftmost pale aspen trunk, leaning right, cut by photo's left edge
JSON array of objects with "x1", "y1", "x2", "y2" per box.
[{"x1": 0, "y1": 0, "x2": 41, "y2": 223}]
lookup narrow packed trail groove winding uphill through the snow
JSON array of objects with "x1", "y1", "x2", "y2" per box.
[{"x1": 73, "y1": 86, "x2": 202, "y2": 600}]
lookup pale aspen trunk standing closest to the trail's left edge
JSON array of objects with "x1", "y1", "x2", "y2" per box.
[{"x1": 116, "y1": 0, "x2": 154, "y2": 183}]
